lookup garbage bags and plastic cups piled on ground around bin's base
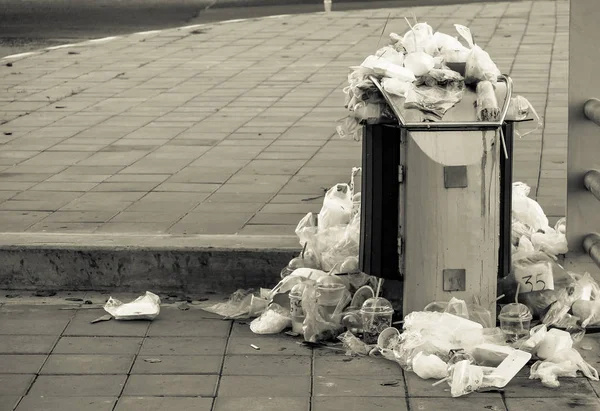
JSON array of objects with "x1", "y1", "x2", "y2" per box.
[{"x1": 205, "y1": 168, "x2": 600, "y2": 397}]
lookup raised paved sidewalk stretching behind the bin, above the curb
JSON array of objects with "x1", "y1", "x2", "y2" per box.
[{"x1": 0, "y1": 0, "x2": 568, "y2": 235}]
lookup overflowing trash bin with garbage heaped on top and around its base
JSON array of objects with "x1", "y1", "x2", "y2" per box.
[{"x1": 205, "y1": 20, "x2": 600, "y2": 397}]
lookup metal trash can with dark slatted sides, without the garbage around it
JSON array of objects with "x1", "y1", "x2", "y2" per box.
[{"x1": 359, "y1": 76, "x2": 514, "y2": 318}]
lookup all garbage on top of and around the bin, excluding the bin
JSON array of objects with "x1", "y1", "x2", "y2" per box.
[{"x1": 205, "y1": 20, "x2": 600, "y2": 397}]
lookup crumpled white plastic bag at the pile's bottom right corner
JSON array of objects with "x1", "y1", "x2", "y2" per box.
[{"x1": 529, "y1": 348, "x2": 598, "y2": 388}]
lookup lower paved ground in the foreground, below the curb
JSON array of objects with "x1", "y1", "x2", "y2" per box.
[{"x1": 0, "y1": 300, "x2": 600, "y2": 411}]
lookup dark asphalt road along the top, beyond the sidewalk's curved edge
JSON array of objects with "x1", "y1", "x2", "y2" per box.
[{"x1": 0, "y1": 0, "x2": 502, "y2": 57}]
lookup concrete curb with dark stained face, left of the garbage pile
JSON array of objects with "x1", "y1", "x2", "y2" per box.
[{"x1": 0, "y1": 233, "x2": 299, "y2": 293}]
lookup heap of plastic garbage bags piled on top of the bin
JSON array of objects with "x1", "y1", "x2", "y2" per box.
[{"x1": 337, "y1": 19, "x2": 540, "y2": 140}]
